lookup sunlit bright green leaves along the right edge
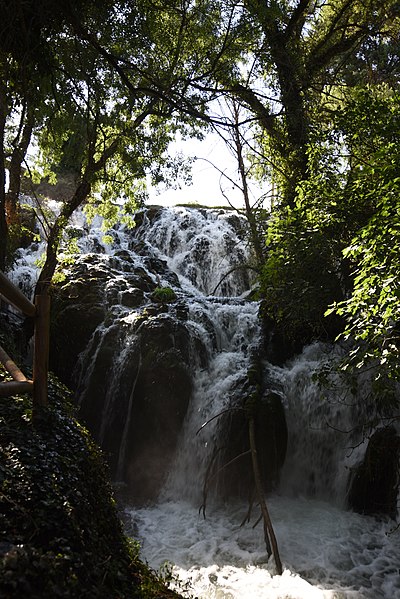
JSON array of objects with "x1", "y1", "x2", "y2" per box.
[{"x1": 328, "y1": 87, "x2": 400, "y2": 400}]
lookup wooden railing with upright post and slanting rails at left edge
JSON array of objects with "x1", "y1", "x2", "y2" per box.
[{"x1": 0, "y1": 271, "x2": 50, "y2": 410}]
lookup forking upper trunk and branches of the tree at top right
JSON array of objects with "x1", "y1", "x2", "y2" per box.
[{"x1": 212, "y1": 0, "x2": 398, "y2": 207}]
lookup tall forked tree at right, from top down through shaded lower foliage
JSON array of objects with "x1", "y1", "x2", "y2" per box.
[{"x1": 203, "y1": 0, "x2": 399, "y2": 360}]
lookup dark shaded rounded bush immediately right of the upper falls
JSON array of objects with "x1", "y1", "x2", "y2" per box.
[{"x1": 260, "y1": 202, "x2": 342, "y2": 343}]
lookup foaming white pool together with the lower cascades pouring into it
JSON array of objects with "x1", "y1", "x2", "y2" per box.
[{"x1": 127, "y1": 346, "x2": 400, "y2": 599}]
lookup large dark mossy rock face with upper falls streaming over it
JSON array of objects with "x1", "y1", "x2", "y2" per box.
[{"x1": 50, "y1": 208, "x2": 276, "y2": 501}]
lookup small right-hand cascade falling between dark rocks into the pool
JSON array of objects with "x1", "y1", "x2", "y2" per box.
[{"x1": 268, "y1": 343, "x2": 366, "y2": 507}]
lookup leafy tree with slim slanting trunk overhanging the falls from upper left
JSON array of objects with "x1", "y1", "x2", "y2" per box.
[{"x1": 0, "y1": 0, "x2": 242, "y2": 291}]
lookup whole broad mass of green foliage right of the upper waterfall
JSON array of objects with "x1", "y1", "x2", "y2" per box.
[{"x1": 261, "y1": 86, "x2": 400, "y2": 360}]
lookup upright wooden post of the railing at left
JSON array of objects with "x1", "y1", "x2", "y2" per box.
[{"x1": 33, "y1": 294, "x2": 50, "y2": 410}]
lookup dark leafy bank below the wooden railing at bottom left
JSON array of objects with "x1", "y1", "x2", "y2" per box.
[{"x1": 0, "y1": 371, "x2": 183, "y2": 599}]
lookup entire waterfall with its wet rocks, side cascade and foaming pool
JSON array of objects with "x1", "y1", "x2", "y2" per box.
[{"x1": 8, "y1": 208, "x2": 400, "y2": 599}]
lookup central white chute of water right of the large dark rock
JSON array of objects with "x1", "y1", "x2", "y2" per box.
[{"x1": 163, "y1": 302, "x2": 260, "y2": 505}]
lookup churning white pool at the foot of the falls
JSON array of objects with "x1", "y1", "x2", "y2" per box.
[{"x1": 127, "y1": 495, "x2": 400, "y2": 599}]
